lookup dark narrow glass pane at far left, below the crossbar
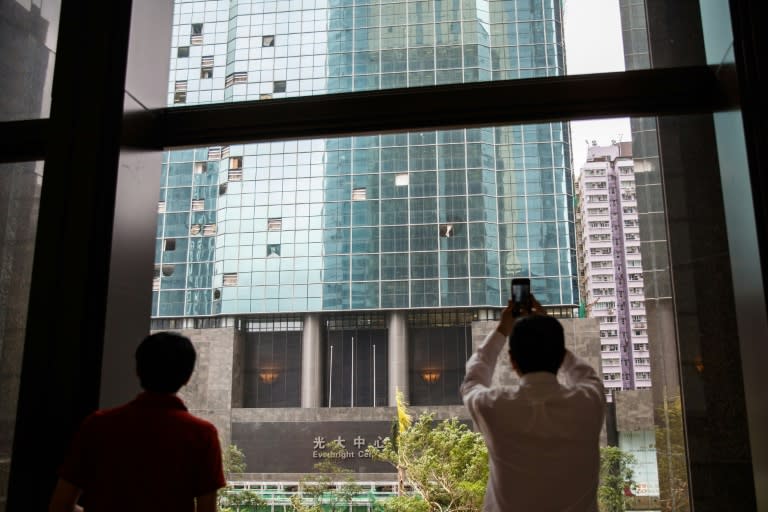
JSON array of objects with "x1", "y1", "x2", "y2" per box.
[{"x1": 0, "y1": 162, "x2": 43, "y2": 503}]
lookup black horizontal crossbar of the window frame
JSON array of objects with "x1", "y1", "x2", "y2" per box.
[{"x1": 0, "y1": 66, "x2": 739, "y2": 163}]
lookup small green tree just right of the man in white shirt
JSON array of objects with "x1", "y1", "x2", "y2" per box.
[{"x1": 597, "y1": 446, "x2": 637, "y2": 512}]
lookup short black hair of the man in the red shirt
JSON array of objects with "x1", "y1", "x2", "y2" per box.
[{"x1": 136, "y1": 332, "x2": 196, "y2": 393}]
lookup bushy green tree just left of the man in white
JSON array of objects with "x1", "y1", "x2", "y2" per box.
[{"x1": 368, "y1": 413, "x2": 488, "y2": 512}]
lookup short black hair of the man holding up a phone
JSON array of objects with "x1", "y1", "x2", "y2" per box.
[{"x1": 509, "y1": 315, "x2": 565, "y2": 374}]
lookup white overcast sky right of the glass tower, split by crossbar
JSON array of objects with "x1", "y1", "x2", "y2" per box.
[{"x1": 564, "y1": 0, "x2": 632, "y2": 170}]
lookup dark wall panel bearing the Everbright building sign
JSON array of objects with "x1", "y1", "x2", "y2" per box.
[{"x1": 232, "y1": 421, "x2": 395, "y2": 473}]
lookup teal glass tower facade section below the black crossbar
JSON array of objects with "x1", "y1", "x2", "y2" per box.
[{"x1": 153, "y1": 127, "x2": 576, "y2": 318}]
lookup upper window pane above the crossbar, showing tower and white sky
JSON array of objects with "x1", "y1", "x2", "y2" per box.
[{"x1": 168, "y1": 0, "x2": 623, "y2": 105}]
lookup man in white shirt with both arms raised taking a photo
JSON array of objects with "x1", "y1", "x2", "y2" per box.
[{"x1": 461, "y1": 299, "x2": 605, "y2": 512}]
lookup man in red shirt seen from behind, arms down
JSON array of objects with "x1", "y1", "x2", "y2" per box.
[{"x1": 49, "y1": 333, "x2": 226, "y2": 512}]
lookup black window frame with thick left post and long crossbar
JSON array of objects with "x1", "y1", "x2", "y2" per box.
[{"x1": 0, "y1": 0, "x2": 768, "y2": 510}]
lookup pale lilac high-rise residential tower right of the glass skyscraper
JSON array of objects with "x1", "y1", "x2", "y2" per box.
[{"x1": 576, "y1": 142, "x2": 651, "y2": 392}]
